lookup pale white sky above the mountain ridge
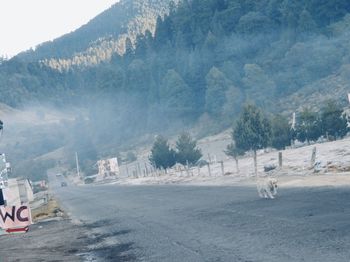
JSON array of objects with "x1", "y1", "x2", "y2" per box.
[{"x1": 0, "y1": 0, "x2": 119, "y2": 56}]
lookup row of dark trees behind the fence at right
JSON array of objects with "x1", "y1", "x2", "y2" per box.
[{"x1": 225, "y1": 101, "x2": 350, "y2": 174}]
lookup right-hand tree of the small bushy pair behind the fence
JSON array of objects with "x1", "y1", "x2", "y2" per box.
[{"x1": 176, "y1": 132, "x2": 202, "y2": 165}]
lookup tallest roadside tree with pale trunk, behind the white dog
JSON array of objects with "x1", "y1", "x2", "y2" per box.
[{"x1": 232, "y1": 104, "x2": 272, "y2": 176}]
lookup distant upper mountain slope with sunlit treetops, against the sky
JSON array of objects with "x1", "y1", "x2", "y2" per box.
[{"x1": 17, "y1": 0, "x2": 179, "y2": 70}]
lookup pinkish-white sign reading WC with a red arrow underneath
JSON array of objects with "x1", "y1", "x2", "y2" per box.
[{"x1": 0, "y1": 206, "x2": 32, "y2": 233}]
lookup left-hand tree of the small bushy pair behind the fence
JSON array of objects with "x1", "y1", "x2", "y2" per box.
[{"x1": 149, "y1": 136, "x2": 176, "y2": 169}]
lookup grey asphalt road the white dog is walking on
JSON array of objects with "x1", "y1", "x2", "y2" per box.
[{"x1": 50, "y1": 177, "x2": 350, "y2": 262}]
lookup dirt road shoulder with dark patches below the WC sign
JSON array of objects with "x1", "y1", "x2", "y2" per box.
[{"x1": 0, "y1": 219, "x2": 134, "y2": 262}]
